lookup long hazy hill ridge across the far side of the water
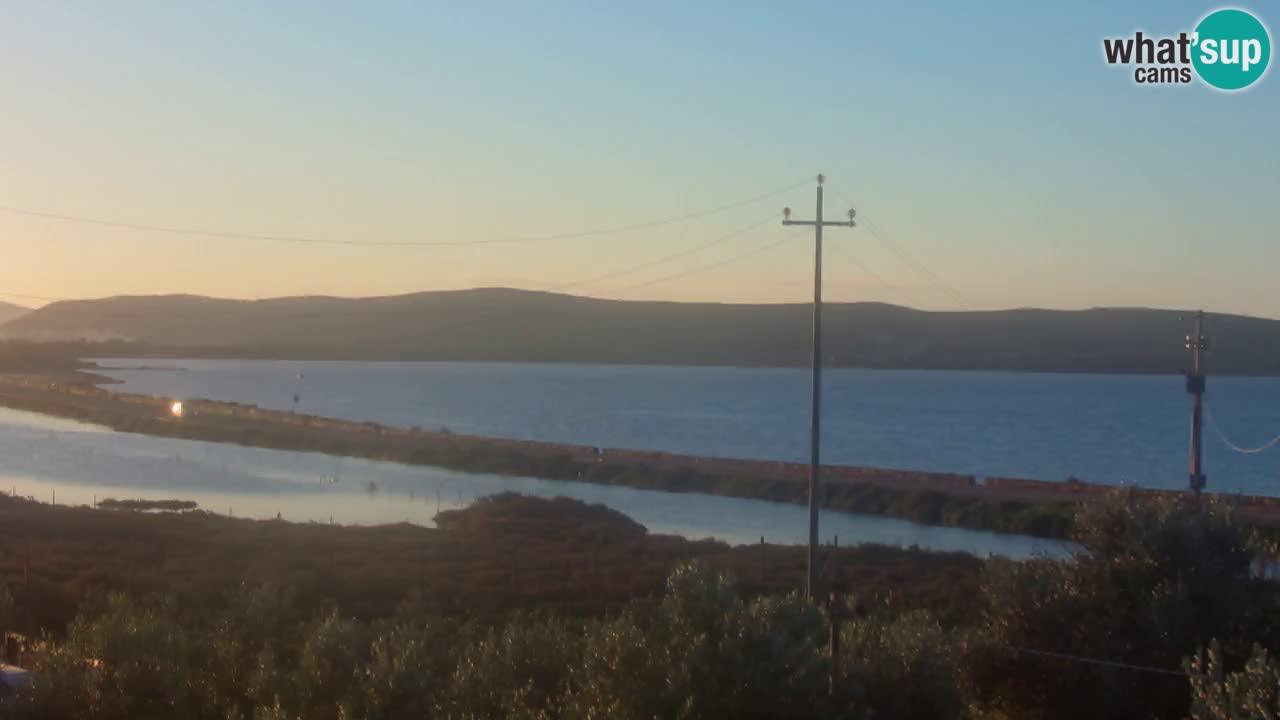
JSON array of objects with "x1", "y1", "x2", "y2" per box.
[{"x1": 0, "y1": 288, "x2": 1280, "y2": 374}]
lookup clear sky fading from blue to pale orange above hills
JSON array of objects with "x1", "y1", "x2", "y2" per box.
[{"x1": 0, "y1": 0, "x2": 1280, "y2": 318}]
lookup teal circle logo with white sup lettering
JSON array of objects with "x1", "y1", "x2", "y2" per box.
[{"x1": 1192, "y1": 9, "x2": 1271, "y2": 90}]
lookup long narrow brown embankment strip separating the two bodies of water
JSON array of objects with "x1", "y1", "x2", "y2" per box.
[{"x1": 0, "y1": 366, "x2": 1280, "y2": 539}]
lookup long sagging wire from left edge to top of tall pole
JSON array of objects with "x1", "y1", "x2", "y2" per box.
[{"x1": 0, "y1": 175, "x2": 808, "y2": 247}]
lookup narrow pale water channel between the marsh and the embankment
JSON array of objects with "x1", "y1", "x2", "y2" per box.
[{"x1": 0, "y1": 409, "x2": 1064, "y2": 557}]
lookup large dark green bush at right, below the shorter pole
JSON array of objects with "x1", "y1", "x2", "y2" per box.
[{"x1": 970, "y1": 492, "x2": 1271, "y2": 719}]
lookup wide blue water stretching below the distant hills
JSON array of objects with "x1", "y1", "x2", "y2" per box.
[{"x1": 94, "y1": 359, "x2": 1280, "y2": 495}]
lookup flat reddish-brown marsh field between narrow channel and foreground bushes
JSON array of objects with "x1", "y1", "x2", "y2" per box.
[{"x1": 0, "y1": 495, "x2": 980, "y2": 632}]
